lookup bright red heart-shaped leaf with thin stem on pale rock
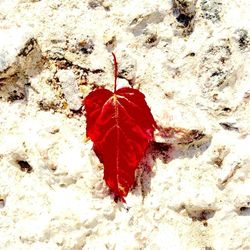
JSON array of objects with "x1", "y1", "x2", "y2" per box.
[{"x1": 83, "y1": 53, "x2": 157, "y2": 202}]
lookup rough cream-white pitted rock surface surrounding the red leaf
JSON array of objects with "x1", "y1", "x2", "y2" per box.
[{"x1": 0, "y1": 0, "x2": 250, "y2": 250}]
